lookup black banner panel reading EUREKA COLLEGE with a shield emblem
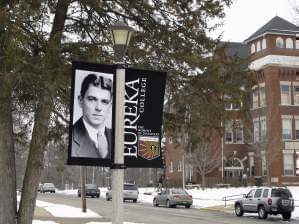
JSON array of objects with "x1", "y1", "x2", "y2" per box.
[{"x1": 124, "y1": 69, "x2": 166, "y2": 168}]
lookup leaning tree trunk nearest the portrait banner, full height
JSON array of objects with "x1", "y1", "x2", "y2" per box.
[{"x1": 17, "y1": 0, "x2": 70, "y2": 224}]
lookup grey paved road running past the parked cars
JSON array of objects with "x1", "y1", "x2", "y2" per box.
[{"x1": 38, "y1": 194, "x2": 299, "y2": 224}]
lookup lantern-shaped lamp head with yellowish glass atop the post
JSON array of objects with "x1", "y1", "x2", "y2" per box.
[{"x1": 110, "y1": 21, "x2": 134, "y2": 63}]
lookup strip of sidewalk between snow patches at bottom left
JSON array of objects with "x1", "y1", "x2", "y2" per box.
[{"x1": 34, "y1": 207, "x2": 111, "y2": 224}]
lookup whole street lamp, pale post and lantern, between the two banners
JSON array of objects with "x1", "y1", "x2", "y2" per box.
[{"x1": 111, "y1": 21, "x2": 133, "y2": 224}]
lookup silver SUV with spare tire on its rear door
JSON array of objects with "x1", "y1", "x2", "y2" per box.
[{"x1": 235, "y1": 187, "x2": 294, "y2": 220}]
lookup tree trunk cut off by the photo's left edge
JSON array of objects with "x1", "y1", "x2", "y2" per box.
[{"x1": 0, "y1": 1, "x2": 17, "y2": 224}]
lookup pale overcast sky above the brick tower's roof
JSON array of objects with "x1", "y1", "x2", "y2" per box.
[{"x1": 218, "y1": 0, "x2": 299, "y2": 42}]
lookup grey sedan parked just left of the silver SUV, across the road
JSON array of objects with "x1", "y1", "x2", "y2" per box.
[{"x1": 153, "y1": 188, "x2": 193, "y2": 208}]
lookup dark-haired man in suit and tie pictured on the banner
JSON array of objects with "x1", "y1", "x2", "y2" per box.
[{"x1": 72, "y1": 74, "x2": 112, "y2": 159}]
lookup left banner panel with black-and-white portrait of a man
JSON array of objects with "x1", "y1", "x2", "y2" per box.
[{"x1": 69, "y1": 62, "x2": 114, "y2": 165}]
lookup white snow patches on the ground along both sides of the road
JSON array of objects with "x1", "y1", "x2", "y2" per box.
[{"x1": 33, "y1": 187, "x2": 299, "y2": 224}]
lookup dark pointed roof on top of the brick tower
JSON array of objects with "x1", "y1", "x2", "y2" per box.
[{"x1": 244, "y1": 16, "x2": 299, "y2": 43}]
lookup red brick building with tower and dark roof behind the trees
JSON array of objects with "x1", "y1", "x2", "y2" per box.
[{"x1": 165, "y1": 16, "x2": 299, "y2": 185}]
